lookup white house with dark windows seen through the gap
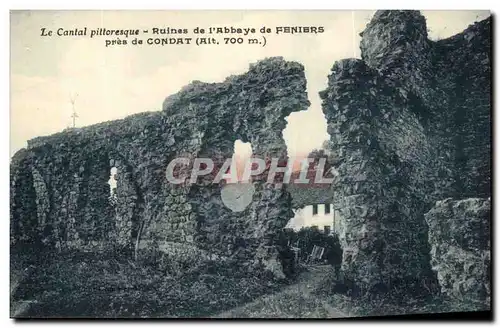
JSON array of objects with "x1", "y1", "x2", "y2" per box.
[{"x1": 286, "y1": 204, "x2": 341, "y2": 234}]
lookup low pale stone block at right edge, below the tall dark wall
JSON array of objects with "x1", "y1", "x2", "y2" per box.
[{"x1": 425, "y1": 198, "x2": 491, "y2": 304}]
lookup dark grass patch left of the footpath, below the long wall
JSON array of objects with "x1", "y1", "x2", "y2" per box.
[{"x1": 11, "y1": 249, "x2": 279, "y2": 318}]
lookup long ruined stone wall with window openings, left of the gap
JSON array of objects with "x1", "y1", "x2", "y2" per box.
[{"x1": 11, "y1": 57, "x2": 309, "y2": 276}]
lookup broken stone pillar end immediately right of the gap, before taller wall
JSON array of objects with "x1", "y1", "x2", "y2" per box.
[{"x1": 321, "y1": 60, "x2": 430, "y2": 292}]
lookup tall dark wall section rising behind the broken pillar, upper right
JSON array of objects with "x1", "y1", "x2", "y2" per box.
[{"x1": 361, "y1": 10, "x2": 491, "y2": 199}]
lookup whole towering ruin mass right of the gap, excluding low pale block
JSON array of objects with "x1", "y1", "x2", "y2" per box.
[{"x1": 321, "y1": 11, "x2": 491, "y2": 298}]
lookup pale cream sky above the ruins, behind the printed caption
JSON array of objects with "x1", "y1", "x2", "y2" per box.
[{"x1": 10, "y1": 10, "x2": 490, "y2": 157}]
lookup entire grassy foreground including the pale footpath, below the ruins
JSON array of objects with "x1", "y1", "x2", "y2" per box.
[{"x1": 11, "y1": 249, "x2": 488, "y2": 318}]
